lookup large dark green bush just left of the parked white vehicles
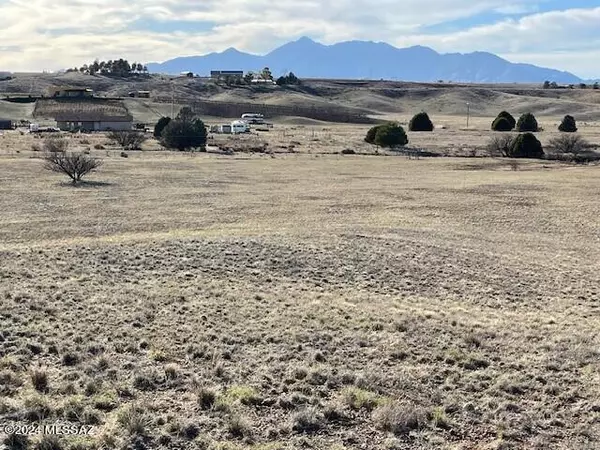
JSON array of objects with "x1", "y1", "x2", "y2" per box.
[{"x1": 162, "y1": 108, "x2": 207, "y2": 151}]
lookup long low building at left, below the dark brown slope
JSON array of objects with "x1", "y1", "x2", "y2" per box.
[{"x1": 55, "y1": 111, "x2": 133, "y2": 131}]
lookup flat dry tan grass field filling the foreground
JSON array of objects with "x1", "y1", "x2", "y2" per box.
[{"x1": 0, "y1": 126, "x2": 600, "y2": 450}]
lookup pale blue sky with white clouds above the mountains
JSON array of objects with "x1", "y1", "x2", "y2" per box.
[{"x1": 0, "y1": 0, "x2": 600, "y2": 79}]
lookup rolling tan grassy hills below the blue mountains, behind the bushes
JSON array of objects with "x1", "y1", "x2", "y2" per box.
[{"x1": 0, "y1": 73, "x2": 600, "y2": 122}]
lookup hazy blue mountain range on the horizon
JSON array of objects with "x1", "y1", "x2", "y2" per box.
[{"x1": 148, "y1": 37, "x2": 582, "y2": 83}]
